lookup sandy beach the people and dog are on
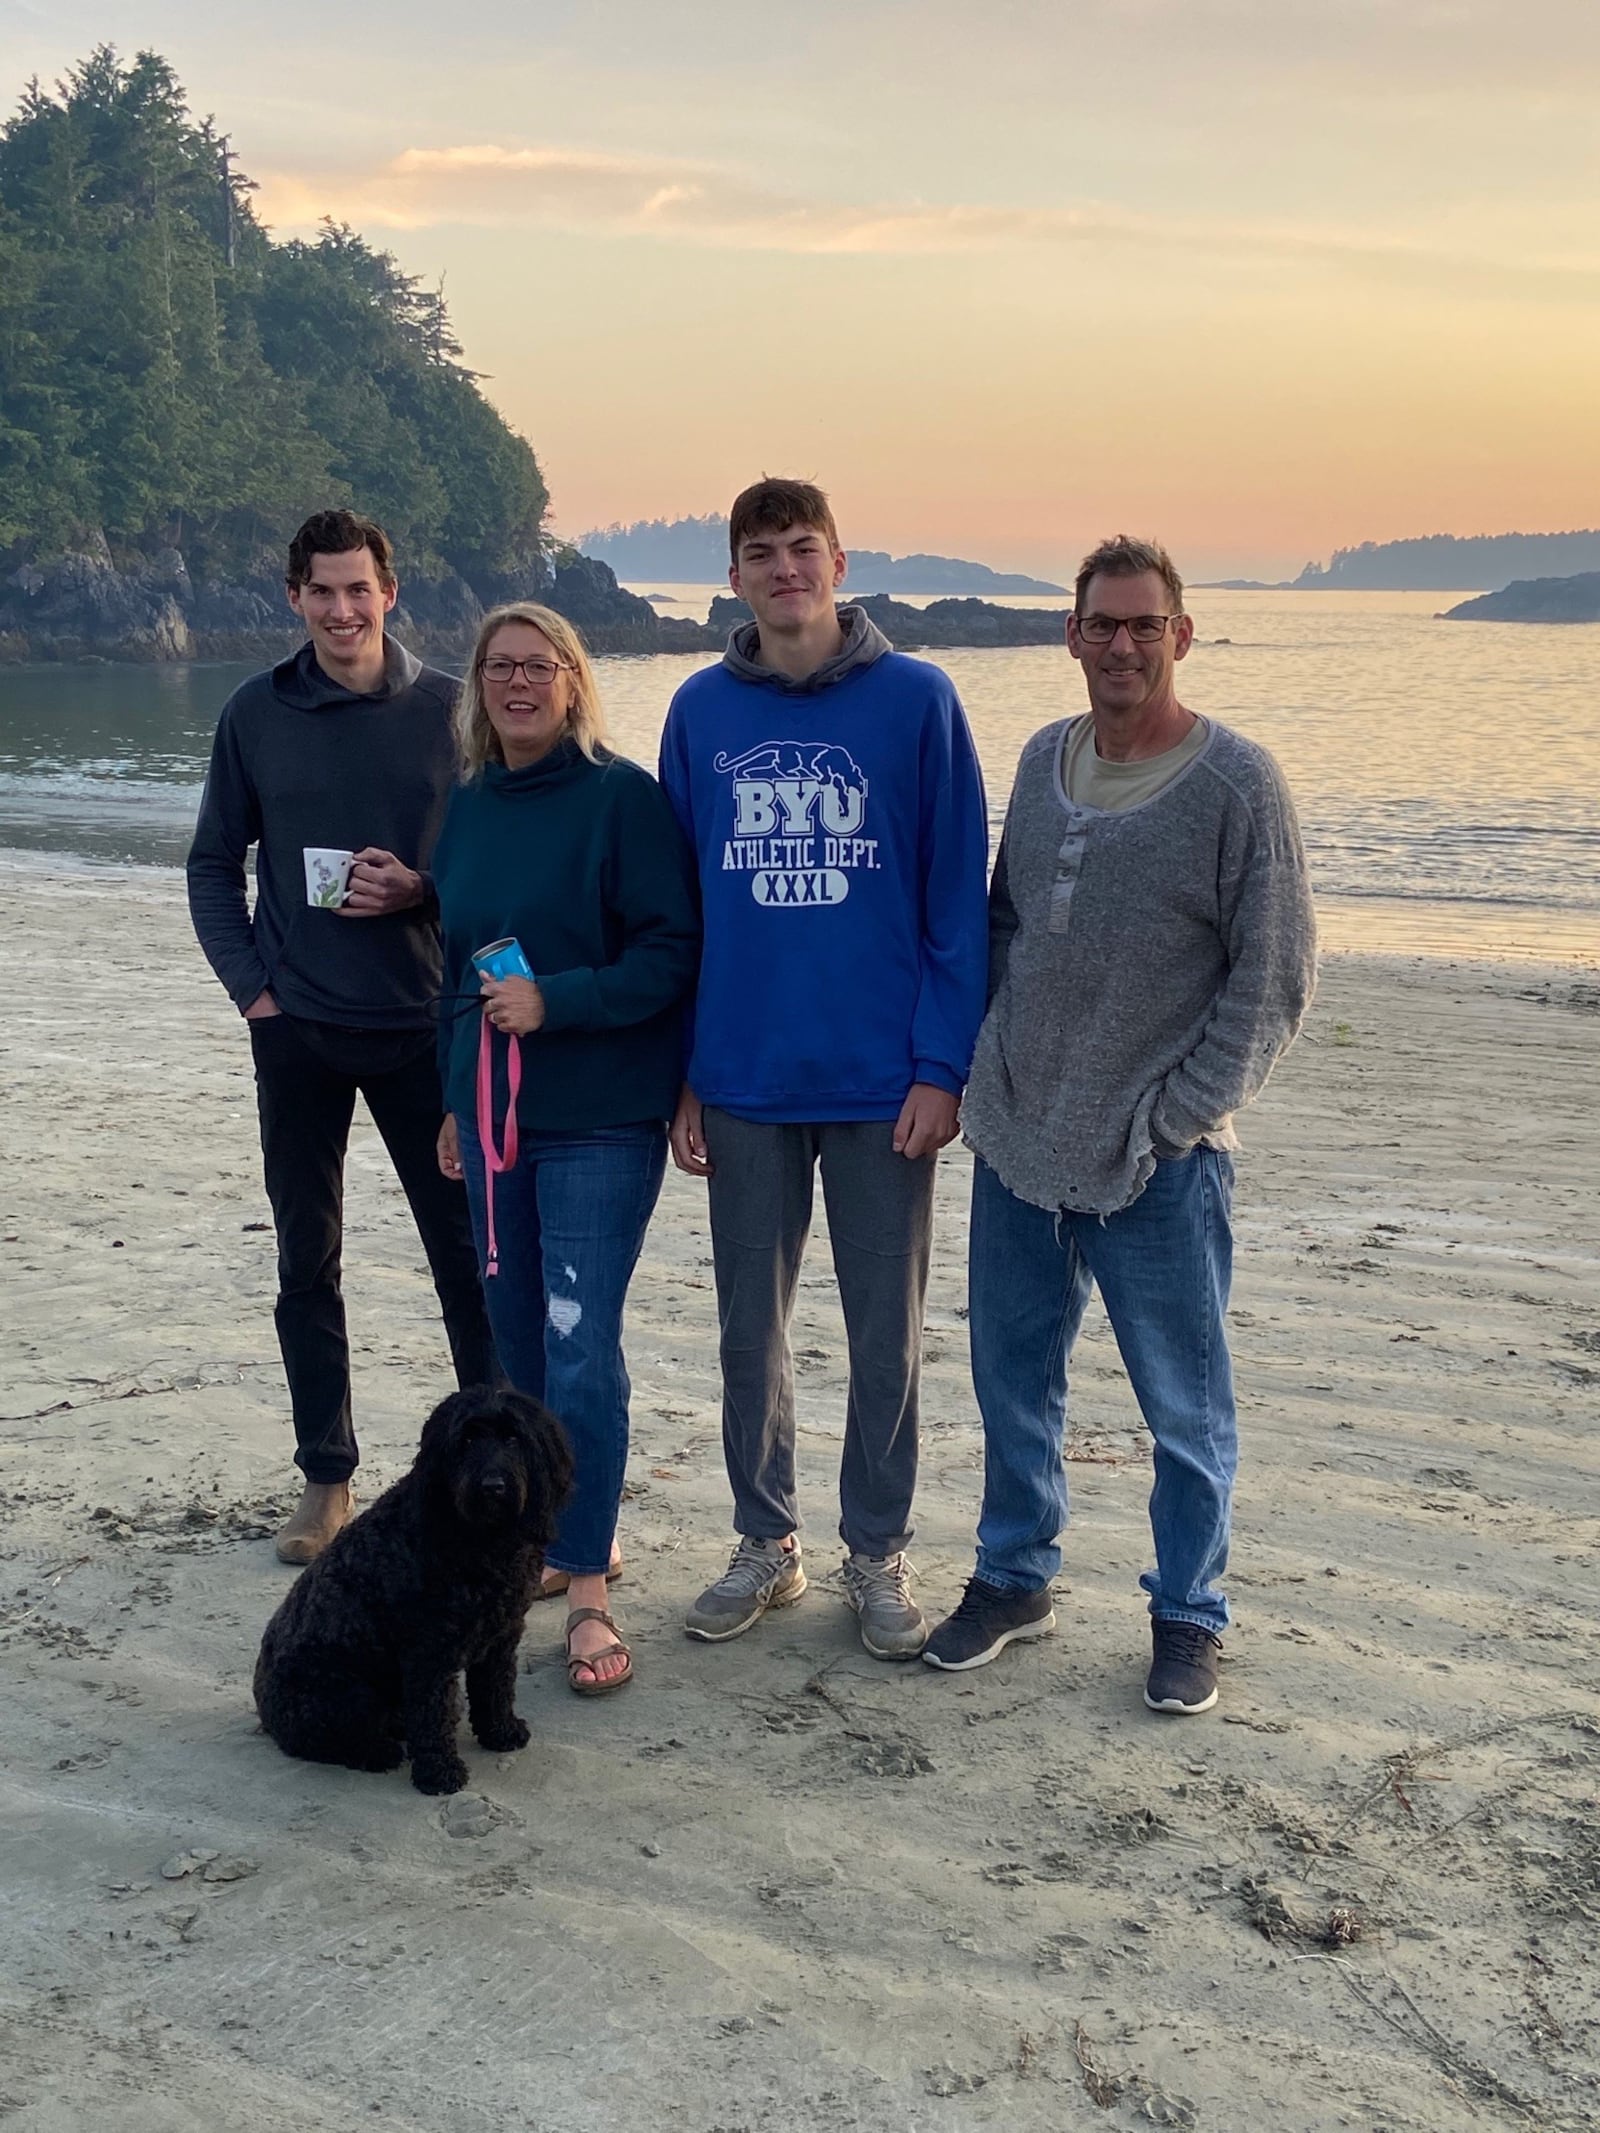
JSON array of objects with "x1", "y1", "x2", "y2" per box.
[{"x1": 0, "y1": 864, "x2": 1600, "y2": 2133}]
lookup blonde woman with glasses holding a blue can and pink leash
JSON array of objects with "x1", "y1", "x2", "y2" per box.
[{"x1": 433, "y1": 604, "x2": 700, "y2": 1696}]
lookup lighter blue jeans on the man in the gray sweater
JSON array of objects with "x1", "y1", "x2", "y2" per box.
[{"x1": 966, "y1": 1148, "x2": 1237, "y2": 1636}]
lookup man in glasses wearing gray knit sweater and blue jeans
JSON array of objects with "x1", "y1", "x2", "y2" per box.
[{"x1": 922, "y1": 535, "x2": 1316, "y2": 1713}]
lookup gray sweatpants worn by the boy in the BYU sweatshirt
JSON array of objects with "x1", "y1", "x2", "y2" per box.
[{"x1": 706, "y1": 1105, "x2": 939, "y2": 1555}]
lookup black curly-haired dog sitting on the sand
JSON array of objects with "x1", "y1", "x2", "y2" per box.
[{"x1": 256, "y1": 1384, "x2": 572, "y2": 1792}]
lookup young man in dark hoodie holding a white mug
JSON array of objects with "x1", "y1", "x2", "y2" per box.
[{"x1": 188, "y1": 510, "x2": 499, "y2": 1563}]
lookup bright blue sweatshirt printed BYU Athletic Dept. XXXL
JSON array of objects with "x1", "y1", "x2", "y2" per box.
[{"x1": 661, "y1": 608, "x2": 988, "y2": 1122}]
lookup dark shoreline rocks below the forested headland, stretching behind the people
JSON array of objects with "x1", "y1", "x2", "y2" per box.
[{"x1": 0, "y1": 538, "x2": 1079, "y2": 665}]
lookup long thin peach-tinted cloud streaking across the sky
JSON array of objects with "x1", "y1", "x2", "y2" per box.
[{"x1": 256, "y1": 143, "x2": 1600, "y2": 296}]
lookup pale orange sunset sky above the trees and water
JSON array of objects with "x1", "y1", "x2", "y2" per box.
[{"x1": 0, "y1": 0, "x2": 1600, "y2": 576}]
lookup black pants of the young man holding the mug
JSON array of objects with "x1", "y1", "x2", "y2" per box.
[{"x1": 250, "y1": 1015, "x2": 501, "y2": 1482}]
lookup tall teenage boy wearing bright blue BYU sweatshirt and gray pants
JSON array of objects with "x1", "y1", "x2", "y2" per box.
[{"x1": 661, "y1": 480, "x2": 988, "y2": 1659}]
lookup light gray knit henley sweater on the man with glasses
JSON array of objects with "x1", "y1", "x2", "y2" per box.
[{"x1": 962, "y1": 719, "x2": 1316, "y2": 1214}]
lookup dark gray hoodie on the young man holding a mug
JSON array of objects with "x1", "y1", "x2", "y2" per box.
[{"x1": 188, "y1": 638, "x2": 457, "y2": 1030}]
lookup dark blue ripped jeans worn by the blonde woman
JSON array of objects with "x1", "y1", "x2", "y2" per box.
[{"x1": 457, "y1": 1113, "x2": 666, "y2": 1576}]
